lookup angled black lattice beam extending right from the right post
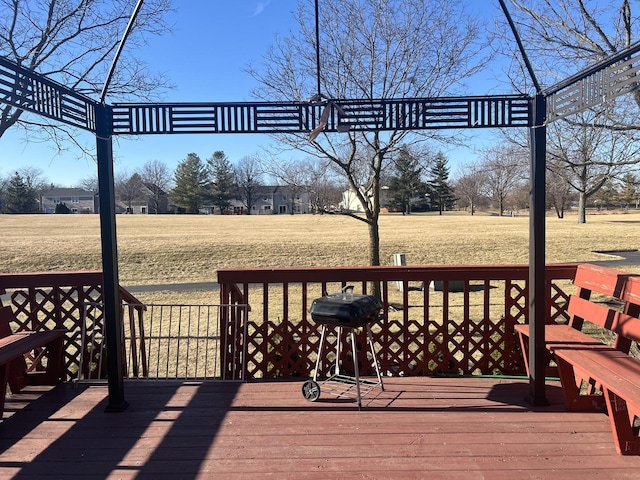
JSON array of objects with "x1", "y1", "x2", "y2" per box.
[{"x1": 542, "y1": 43, "x2": 640, "y2": 122}]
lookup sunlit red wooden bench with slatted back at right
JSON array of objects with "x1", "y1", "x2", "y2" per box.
[{"x1": 515, "y1": 264, "x2": 640, "y2": 455}]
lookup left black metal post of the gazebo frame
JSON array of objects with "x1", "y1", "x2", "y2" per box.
[{"x1": 95, "y1": 104, "x2": 129, "y2": 412}]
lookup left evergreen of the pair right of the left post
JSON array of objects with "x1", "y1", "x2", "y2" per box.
[{"x1": 169, "y1": 153, "x2": 208, "y2": 213}]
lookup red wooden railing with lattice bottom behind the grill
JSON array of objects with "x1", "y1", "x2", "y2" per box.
[{"x1": 218, "y1": 264, "x2": 577, "y2": 379}]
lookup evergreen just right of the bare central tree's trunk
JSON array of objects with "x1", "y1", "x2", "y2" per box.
[{"x1": 389, "y1": 145, "x2": 426, "y2": 213}]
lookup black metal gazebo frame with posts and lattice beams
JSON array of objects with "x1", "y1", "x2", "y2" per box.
[{"x1": 0, "y1": 27, "x2": 640, "y2": 411}]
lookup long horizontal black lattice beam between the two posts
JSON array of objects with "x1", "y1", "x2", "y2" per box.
[{"x1": 113, "y1": 95, "x2": 531, "y2": 135}]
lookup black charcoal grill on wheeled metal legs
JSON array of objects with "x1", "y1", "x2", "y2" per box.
[{"x1": 302, "y1": 286, "x2": 384, "y2": 409}]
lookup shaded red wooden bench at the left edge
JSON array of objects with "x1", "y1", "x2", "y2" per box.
[{"x1": 0, "y1": 307, "x2": 65, "y2": 418}]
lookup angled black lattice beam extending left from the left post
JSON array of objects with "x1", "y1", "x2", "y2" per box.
[{"x1": 0, "y1": 57, "x2": 96, "y2": 132}]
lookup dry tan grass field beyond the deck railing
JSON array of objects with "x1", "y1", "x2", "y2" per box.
[{"x1": 0, "y1": 212, "x2": 640, "y2": 300}]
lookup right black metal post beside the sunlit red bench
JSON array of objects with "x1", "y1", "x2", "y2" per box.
[{"x1": 527, "y1": 93, "x2": 548, "y2": 405}]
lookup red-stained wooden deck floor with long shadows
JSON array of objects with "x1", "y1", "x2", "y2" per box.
[{"x1": 0, "y1": 377, "x2": 640, "y2": 480}]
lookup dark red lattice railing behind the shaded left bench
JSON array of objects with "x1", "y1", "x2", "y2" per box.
[{"x1": 0, "y1": 271, "x2": 146, "y2": 380}]
